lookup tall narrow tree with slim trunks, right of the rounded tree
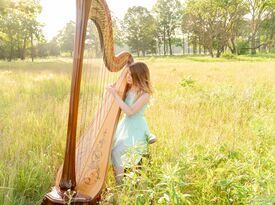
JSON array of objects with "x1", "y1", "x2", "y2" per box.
[{"x1": 153, "y1": 0, "x2": 181, "y2": 55}]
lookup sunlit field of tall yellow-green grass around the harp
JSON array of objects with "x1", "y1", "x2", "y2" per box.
[{"x1": 0, "y1": 56, "x2": 275, "y2": 205}]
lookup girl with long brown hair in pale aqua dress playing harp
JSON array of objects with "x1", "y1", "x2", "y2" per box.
[{"x1": 107, "y1": 62, "x2": 156, "y2": 184}]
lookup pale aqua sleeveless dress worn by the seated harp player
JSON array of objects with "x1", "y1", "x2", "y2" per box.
[{"x1": 112, "y1": 91, "x2": 150, "y2": 168}]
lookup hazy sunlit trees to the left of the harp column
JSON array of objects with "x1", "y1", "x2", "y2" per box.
[{"x1": 0, "y1": 0, "x2": 81, "y2": 61}]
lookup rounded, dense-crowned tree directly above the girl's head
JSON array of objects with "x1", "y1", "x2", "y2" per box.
[{"x1": 123, "y1": 6, "x2": 156, "y2": 56}]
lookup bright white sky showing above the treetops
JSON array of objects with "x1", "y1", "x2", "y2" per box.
[{"x1": 38, "y1": 0, "x2": 157, "y2": 40}]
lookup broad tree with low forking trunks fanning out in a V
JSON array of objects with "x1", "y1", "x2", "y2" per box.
[{"x1": 186, "y1": 0, "x2": 247, "y2": 57}]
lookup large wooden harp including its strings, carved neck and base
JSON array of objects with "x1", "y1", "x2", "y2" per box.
[{"x1": 42, "y1": 0, "x2": 133, "y2": 204}]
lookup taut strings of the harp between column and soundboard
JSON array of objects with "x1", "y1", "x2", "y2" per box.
[{"x1": 76, "y1": 20, "x2": 120, "y2": 181}]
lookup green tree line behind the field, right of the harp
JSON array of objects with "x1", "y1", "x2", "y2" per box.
[{"x1": 121, "y1": 0, "x2": 275, "y2": 57}]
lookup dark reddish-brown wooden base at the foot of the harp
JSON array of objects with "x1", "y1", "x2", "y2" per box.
[{"x1": 41, "y1": 187, "x2": 98, "y2": 205}]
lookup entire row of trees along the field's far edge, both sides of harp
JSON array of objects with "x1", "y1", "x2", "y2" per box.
[{"x1": 0, "y1": 0, "x2": 275, "y2": 61}]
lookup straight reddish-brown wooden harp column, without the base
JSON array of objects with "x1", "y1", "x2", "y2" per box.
[{"x1": 59, "y1": 0, "x2": 92, "y2": 191}]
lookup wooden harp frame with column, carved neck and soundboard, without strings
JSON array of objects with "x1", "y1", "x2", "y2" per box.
[{"x1": 42, "y1": 0, "x2": 133, "y2": 204}]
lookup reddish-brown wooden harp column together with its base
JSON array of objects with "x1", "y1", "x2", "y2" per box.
[{"x1": 42, "y1": 0, "x2": 96, "y2": 205}]
